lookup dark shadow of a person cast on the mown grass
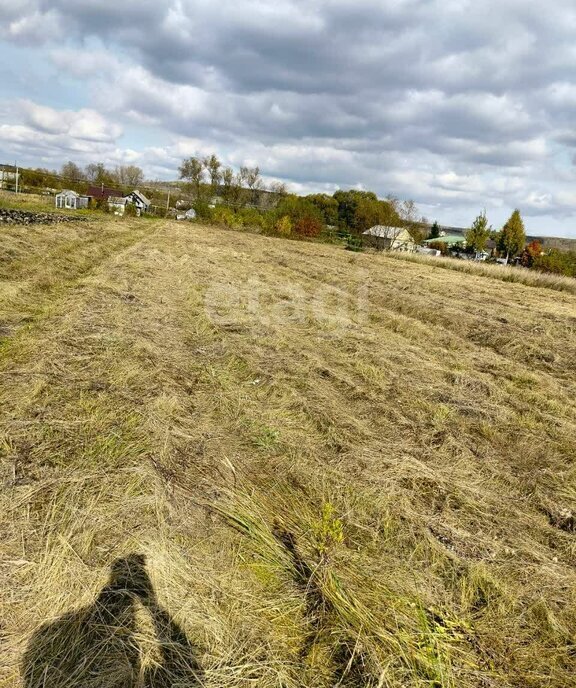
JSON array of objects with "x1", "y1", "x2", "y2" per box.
[{"x1": 22, "y1": 554, "x2": 202, "y2": 688}]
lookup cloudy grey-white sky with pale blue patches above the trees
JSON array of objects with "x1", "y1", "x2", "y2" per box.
[{"x1": 0, "y1": 0, "x2": 576, "y2": 237}]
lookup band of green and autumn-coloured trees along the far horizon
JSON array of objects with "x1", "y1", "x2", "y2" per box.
[{"x1": 5, "y1": 154, "x2": 576, "y2": 277}]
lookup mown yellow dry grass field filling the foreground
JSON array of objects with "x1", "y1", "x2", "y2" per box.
[{"x1": 0, "y1": 219, "x2": 576, "y2": 688}]
